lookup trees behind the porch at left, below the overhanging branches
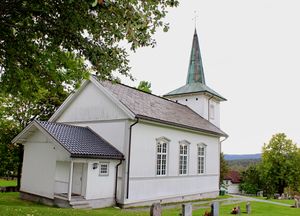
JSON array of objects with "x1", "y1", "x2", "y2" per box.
[{"x1": 0, "y1": 93, "x2": 67, "y2": 186}]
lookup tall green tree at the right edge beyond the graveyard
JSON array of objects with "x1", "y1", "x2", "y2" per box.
[{"x1": 261, "y1": 133, "x2": 300, "y2": 195}]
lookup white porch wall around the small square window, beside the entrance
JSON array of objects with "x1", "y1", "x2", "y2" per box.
[{"x1": 86, "y1": 160, "x2": 119, "y2": 199}]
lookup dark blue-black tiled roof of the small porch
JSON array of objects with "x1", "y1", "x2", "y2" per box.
[{"x1": 36, "y1": 121, "x2": 123, "y2": 159}]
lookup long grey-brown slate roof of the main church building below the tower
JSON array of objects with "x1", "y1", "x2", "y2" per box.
[{"x1": 100, "y1": 81, "x2": 227, "y2": 136}]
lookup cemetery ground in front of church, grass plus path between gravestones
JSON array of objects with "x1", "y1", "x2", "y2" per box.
[{"x1": 0, "y1": 192, "x2": 300, "y2": 216}]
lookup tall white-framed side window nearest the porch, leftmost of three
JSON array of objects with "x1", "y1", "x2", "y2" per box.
[{"x1": 155, "y1": 137, "x2": 170, "y2": 176}]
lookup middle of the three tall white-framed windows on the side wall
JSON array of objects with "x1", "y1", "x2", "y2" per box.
[{"x1": 178, "y1": 140, "x2": 190, "y2": 176}]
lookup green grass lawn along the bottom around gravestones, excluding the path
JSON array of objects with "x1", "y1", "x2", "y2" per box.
[{"x1": 0, "y1": 193, "x2": 300, "y2": 216}]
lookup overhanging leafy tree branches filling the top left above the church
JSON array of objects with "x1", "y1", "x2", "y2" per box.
[{"x1": 0, "y1": 0, "x2": 178, "y2": 94}]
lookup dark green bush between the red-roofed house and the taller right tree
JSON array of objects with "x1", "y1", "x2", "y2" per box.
[{"x1": 240, "y1": 165, "x2": 262, "y2": 194}]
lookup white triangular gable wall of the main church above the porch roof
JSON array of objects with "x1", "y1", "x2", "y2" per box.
[{"x1": 56, "y1": 82, "x2": 127, "y2": 122}]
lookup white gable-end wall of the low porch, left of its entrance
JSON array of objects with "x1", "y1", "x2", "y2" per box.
[{"x1": 21, "y1": 130, "x2": 69, "y2": 198}]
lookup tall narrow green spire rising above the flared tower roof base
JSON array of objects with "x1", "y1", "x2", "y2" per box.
[{"x1": 186, "y1": 29, "x2": 205, "y2": 84}]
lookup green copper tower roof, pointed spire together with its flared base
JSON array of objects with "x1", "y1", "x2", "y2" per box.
[{"x1": 164, "y1": 29, "x2": 226, "y2": 101}]
